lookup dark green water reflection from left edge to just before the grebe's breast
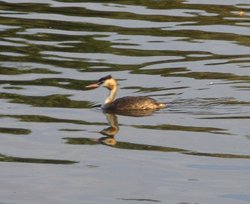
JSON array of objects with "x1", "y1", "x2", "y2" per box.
[{"x1": 0, "y1": 93, "x2": 93, "y2": 108}]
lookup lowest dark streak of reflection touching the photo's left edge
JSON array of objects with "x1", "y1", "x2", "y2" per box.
[{"x1": 0, "y1": 154, "x2": 77, "y2": 165}]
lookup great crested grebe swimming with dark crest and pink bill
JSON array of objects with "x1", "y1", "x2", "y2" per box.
[{"x1": 86, "y1": 75, "x2": 167, "y2": 111}]
